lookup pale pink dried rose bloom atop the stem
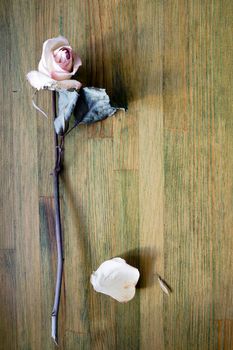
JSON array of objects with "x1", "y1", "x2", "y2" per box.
[{"x1": 27, "y1": 36, "x2": 82, "y2": 90}]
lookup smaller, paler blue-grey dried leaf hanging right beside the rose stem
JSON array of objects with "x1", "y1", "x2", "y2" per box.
[{"x1": 54, "y1": 90, "x2": 79, "y2": 135}]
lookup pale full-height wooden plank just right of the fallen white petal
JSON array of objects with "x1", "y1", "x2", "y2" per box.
[{"x1": 137, "y1": 1, "x2": 165, "y2": 349}]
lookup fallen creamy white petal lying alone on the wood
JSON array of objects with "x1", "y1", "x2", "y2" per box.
[{"x1": 90, "y1": 258, "x2": 140, "y2": 303}]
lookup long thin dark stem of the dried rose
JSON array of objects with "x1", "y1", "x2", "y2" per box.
[{"x1": 51, "y1": 91, "x2": 64, "y2": 345}]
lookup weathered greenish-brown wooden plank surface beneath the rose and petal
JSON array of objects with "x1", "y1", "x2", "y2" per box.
[{"x1": 0, "y1": 0, "x2": 233, "y2": 350}]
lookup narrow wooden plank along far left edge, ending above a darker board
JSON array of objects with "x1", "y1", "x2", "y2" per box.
[{"x1": 0, "y1": 2, "x2": 14, "y2": 249}]
